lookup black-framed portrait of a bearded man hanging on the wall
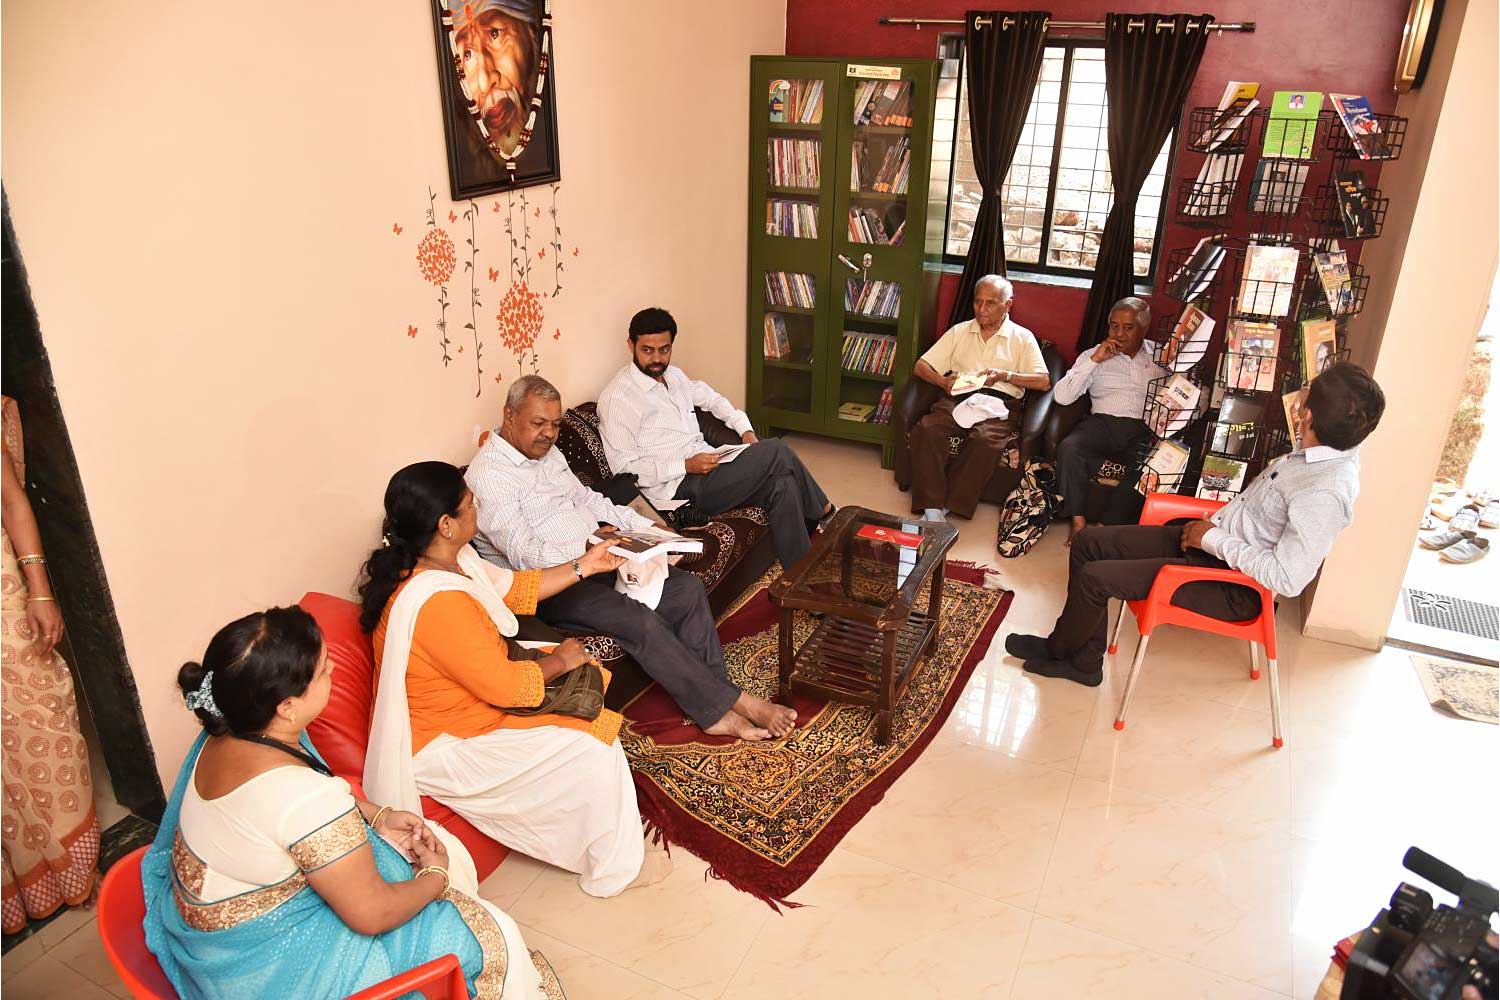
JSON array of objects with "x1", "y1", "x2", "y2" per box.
[{"x1": 431, "y1": 0, "x2": 563, "y2": 201}]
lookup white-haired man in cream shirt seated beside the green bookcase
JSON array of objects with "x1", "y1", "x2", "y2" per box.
[{"x1": 908, "y1": 274, "x2": 1052, "y2": 520}]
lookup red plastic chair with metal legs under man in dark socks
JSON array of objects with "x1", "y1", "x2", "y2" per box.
[{"x1": 1110, "y1": 493, "x2": 1283, "y2": 747}]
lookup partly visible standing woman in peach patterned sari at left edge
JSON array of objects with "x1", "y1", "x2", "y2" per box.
[{"x1": 0, "y1": 396, "x2": 99, "y2": 934}]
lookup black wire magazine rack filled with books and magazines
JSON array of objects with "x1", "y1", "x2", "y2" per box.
[{"x1": 1134, "y1": 91, "x2": 1407, "y2": 499}]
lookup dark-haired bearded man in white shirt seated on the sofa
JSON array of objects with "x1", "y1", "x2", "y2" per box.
[{"x1": 599, "y1": 307, "x2": 833, "y2": 570}]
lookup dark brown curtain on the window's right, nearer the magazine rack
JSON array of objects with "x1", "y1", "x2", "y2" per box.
[{"x1": 1079, "y1": 13, "x2": 1214, "y2": 351}]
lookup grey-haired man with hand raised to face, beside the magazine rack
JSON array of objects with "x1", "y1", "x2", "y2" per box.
[{"x1": 1052, "y1": 295, "x2": 1169, "y2": 544}]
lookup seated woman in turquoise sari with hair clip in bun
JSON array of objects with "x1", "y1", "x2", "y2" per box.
[{"x1": 141, "y1": 607, "x2": 563, "y2": 1000}]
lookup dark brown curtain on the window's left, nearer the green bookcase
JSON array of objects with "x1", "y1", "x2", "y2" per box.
[{"x1": 948, "y1": 10, "x2": 1052, "y2": 325}]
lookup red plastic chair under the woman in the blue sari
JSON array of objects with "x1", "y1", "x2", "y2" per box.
[{"x1": 98, "y1": 847, "x2": 468, "y2": 1000}]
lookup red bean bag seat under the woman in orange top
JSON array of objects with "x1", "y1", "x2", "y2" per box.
[{"x1": 297, "y1": 594, "x2": 510, "y2": 882}]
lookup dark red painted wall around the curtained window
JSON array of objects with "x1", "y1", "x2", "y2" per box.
[{"x1": 786, "y1": 0, "x2": 1410, "y2": 358}]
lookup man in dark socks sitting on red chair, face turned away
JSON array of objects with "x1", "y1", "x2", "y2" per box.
[{"x1": 1005, "y1": 361, "x2": 1386, "y2": 687}]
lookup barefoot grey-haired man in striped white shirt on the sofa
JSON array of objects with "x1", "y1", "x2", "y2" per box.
[{"x1": 464, "y1": 375, "x2": 797, "y2": 739}]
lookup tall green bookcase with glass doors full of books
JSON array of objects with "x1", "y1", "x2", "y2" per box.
[{"x1": 746, "y1": 55, "x2": 938, "y2": 466}]
